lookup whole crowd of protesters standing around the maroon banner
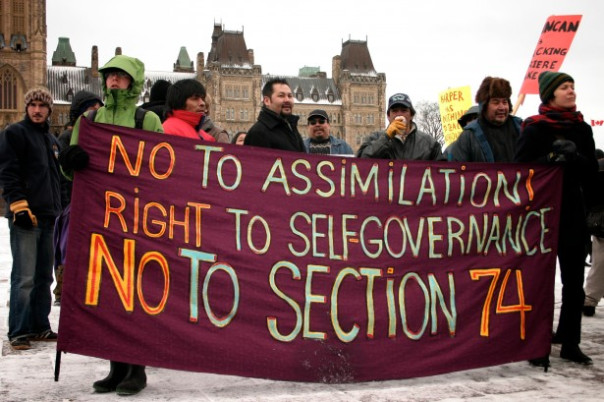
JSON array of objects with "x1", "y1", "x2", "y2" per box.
[{"x1": 0, "y1": 49, "x2": 604, "y2": 395}]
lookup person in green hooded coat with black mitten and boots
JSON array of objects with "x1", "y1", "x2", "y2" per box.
[{"x1": 59, "y1": 55, "x2": 163, "y2": 395}]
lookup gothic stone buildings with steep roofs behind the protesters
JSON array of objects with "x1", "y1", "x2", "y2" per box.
[{"x1": 0, "y1": 0, "x2": 386, "y2": 149}]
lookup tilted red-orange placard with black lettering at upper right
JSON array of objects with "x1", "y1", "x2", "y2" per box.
[{"x1": 519, "y1": 15, "x2": 582, "y2": 94}]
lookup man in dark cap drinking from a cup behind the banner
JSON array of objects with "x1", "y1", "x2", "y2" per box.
[{"x1": 357, "y1": 93, "x2": 444, "y2": 160}]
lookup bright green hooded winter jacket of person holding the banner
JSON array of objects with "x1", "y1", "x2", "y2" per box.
[{"x1": 70, "y1": 55, "x2": 164, "y2": 145}]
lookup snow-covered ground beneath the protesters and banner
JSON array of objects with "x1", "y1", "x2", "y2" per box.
[{"x1": 0, "y1": 218, "x2": 604, "y2": 402}]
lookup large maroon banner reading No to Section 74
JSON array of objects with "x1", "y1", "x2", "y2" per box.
[{"x1": 58, "y1": 119, "x2": 562, "y2": 382}]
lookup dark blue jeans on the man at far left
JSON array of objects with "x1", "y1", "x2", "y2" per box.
[{"x1": 8, "y1": 218, "x2": 54, "y2": 339}]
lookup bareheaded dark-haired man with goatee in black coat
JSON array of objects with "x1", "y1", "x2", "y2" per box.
[{"x1": 244, "y1": 78, "x2": 306, "y2": 152}]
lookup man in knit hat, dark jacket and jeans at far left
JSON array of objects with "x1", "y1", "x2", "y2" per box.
[{"x1": 0, "y1": 88, "x2": 61, "y2": 350}]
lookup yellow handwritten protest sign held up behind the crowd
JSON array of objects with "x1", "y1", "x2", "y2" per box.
[{"x1": 438, "y1": 86, "x2": 472, "y2": 145}]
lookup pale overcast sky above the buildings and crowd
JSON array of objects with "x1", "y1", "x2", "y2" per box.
[{"x1": 46, "y1": 0, "x2": 604, "y2": 147}]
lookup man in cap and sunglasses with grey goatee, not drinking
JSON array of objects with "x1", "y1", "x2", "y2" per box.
[{"x1": 304, "y1": 109, "x2": 354, "y2": 155}]
